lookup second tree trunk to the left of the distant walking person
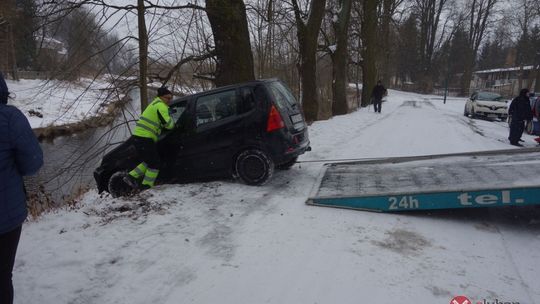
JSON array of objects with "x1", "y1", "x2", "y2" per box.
[{"x1": 332, "y1": 0, "x2": 352, "y2": 115}]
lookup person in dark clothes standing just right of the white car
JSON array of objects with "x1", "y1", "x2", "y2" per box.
[{"x1": 508, "y1": 89, "x2": 533, "y2": 147}]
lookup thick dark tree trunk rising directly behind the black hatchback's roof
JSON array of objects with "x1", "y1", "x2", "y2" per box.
[{"x1": 206, "y1": 0, "x2": 255, "y2": 87}]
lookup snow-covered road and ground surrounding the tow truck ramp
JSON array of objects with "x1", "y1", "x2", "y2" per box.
[{"x1": 14, "y1": 91, "x2": 540, "y2": 304}]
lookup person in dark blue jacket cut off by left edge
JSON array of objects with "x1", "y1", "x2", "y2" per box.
[{"x1": 0, "y1": 73, "x2": 43, "y2": 304}]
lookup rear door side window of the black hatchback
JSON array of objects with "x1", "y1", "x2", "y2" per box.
[{"x1": 195, "y1": 90, "x2": 238, "y2": 127}]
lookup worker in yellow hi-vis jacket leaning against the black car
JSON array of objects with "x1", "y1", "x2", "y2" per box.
[{"x1": 124, "y1": 87, "x2": 174, "y2": 190}]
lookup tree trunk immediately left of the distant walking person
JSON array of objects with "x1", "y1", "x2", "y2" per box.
[{"x1": 362, "y1": 0, "x2": 378, "y2": 107}]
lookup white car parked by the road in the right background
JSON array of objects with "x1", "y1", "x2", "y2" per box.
[{"x1": 463, "y1": 92, "x2": 508, "y2": 120}]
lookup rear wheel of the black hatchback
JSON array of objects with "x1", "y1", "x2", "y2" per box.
[{"x1": 235, "y1": 149, "x2": 274, "y2": 185}]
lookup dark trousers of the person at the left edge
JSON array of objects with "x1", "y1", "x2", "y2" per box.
[{"x1": 0, "y1": 226, "x2": 22, "y2": 304}]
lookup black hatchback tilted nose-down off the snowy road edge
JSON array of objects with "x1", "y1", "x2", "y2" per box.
[{"x1": 94, "y1": 79, "x2": 310, "y2": 194}]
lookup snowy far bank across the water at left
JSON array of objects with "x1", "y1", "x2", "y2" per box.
[{"x1": 6, "y1": 79, "x2": 123, "y2": 128}]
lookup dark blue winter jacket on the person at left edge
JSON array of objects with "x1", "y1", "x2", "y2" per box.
[{"x1": 0, "y1": 103, "x2": 43, "y2": 234}]
